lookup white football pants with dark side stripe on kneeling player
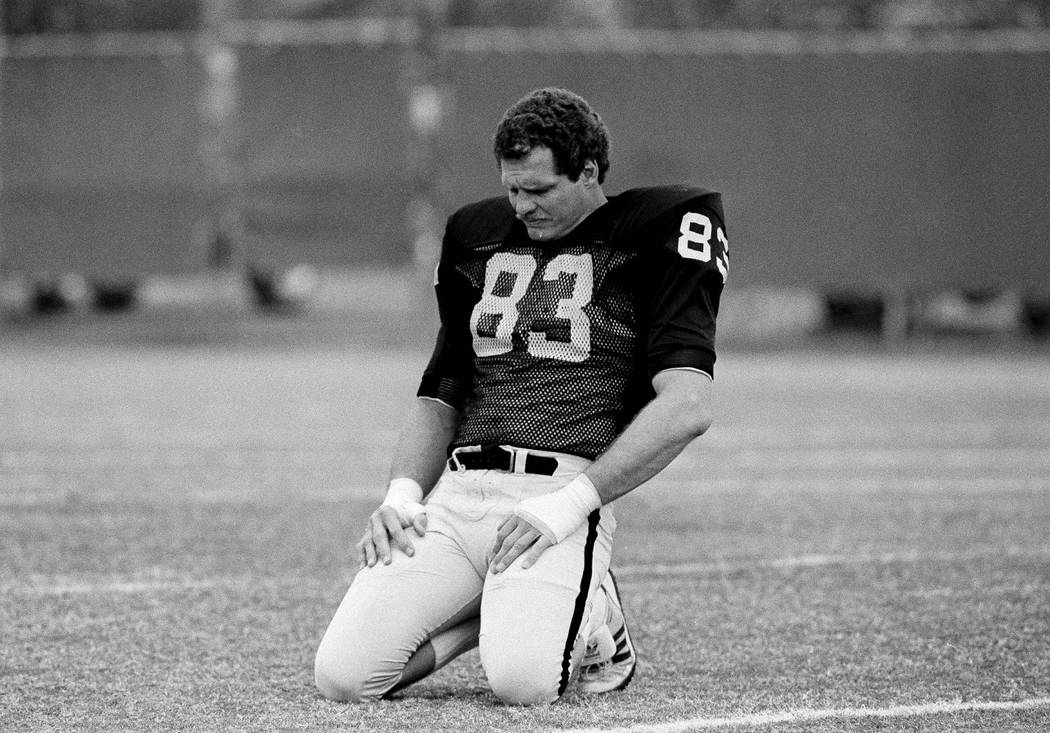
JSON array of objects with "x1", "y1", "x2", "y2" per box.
[{"x1": 314, "y1": 452, "x2": 615, "y2": 705}]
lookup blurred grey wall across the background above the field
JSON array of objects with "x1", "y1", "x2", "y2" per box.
[{"x1": 0, "y1": 0, "x2": 1050, "y2": 291}]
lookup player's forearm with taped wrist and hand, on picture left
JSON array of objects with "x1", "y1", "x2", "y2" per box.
[{"x1": 357, "y1": 398, "x2": 460, "y2": 567}]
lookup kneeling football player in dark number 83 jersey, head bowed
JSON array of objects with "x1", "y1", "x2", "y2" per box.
[{"x1": 315, "y1": 88, "x2": 729, "y2": 705}]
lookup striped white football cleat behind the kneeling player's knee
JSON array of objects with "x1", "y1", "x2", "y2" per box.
[{"x1": 578, "y1": 570, "x2": 638, "y2": 694}]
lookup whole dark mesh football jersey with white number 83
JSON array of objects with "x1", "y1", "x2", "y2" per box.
[{"x1": 418, "y1": 187, "x2": 729, "y2": 458}]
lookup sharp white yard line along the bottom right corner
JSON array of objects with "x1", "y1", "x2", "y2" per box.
[{"x1": 563, "y1": 697, "x2": 1050, "y2": 733}]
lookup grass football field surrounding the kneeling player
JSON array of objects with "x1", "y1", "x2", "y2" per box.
[{"x1": 0, "y1": 308, "x2": 1050, "y2": 732}]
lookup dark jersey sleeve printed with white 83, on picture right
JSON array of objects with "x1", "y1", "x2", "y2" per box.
[{"x1": 646, "y1": 195, "x2": 729, "y2": 378}]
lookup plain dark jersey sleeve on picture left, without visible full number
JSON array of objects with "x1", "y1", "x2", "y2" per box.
[{"x1": 416, "y1": 211, "x2": 473, "y2": 410}]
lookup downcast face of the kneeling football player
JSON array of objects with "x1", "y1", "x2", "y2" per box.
[{"x1": 500, "y1": 147, "x2": 602, "y2": 242}]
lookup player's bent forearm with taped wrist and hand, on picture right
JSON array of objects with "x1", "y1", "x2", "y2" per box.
[{"x1": 489, "y1": 370, "x2": 713, "y2": 572}]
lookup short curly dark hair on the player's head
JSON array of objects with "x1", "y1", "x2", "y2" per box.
[{"x1": 492, "y1": 87, "x2": 609, "y2": 183}]
